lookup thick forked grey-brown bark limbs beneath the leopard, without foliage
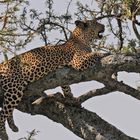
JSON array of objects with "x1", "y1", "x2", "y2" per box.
[{"x1": 0, "y1": 54, "x2": 140, "y2": 140}]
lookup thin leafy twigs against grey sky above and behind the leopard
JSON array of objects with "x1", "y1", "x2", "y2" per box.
[{"x1": 0, "y1": 0, "x2": 140, "y2": 59}]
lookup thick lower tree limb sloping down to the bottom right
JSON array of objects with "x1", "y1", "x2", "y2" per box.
[{"x1": 0, "y1": 96, "x2": 136, "y2": 140}]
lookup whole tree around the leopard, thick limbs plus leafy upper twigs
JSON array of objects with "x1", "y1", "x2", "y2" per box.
[{"x1": 0, "y1": 0, "x2": 140, "y2": 140}]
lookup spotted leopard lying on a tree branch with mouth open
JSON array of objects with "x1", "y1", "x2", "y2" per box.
[{"x1": 0, "y1": 19, "x2": 105, "y2": 140}]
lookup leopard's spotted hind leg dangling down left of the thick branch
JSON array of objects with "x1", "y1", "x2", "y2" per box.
[{"x1": 0, "y1": 87, "x2": 23, "y2": 140}]
